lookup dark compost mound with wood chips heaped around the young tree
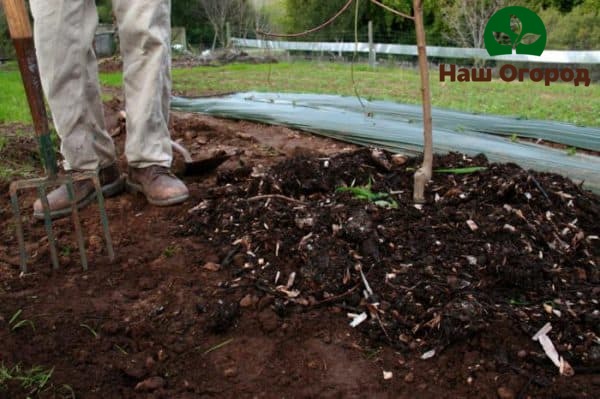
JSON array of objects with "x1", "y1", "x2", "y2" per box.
[{"x1": 182, "y1": 149, "x2": 600, "y2": 369}]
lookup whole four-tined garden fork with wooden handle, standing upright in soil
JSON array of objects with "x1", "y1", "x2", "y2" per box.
[{"x1": 2, "y1": 0, "x2": 115, "y2": 273}]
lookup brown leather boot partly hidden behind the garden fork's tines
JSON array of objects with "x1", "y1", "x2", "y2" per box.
[{"x1": 33, "y1": 164, "x2": 125, "y2": 220}]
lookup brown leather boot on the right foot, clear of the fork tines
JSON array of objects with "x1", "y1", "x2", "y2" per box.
[{"x1": 127, "y1": 165, "x2": 190, "y2": 206}]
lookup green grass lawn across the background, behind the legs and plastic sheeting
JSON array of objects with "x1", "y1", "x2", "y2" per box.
[{"x1": 0, "y1": 62, "x2": 600, "y2": 126}]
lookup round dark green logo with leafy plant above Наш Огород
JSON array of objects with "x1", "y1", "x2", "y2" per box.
[{"x1": 483, "y1": 6, "x2": 548, "y2": 56}]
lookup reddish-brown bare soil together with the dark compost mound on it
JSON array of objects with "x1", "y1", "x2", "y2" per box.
[{"x1": 0, "y1": 101, "x2": 600, "y2": 398}]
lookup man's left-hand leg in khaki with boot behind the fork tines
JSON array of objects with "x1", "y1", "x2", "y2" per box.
[{"x1": 30, "y1": 0, "x2": 123, "y2": 222}]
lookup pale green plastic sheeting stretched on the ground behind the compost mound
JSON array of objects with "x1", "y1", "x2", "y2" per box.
[{"x1": 171, "y1": 92, "x2": 600, "y2": 193}]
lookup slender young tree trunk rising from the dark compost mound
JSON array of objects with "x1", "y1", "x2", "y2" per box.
[{"x1": 413, "y1": 0, "x2": 433, "y2": 204}]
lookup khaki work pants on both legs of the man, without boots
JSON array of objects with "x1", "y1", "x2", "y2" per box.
[{"x1": 30, "y1": 0, "x2": 172, "y2": 170}]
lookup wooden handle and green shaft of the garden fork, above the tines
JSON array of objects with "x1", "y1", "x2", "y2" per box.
[{"x1": 2, "y1": 0, "x2": 57, "y2": 177}]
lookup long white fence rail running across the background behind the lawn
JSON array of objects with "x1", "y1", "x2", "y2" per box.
[{"x1": 231, "y1": 38, "x2": 600, "y2": 64}]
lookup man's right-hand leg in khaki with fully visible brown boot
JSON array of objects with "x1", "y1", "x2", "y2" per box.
[{"x1": 113, "y1": 0, "x2": 188, "y2": 205}]
